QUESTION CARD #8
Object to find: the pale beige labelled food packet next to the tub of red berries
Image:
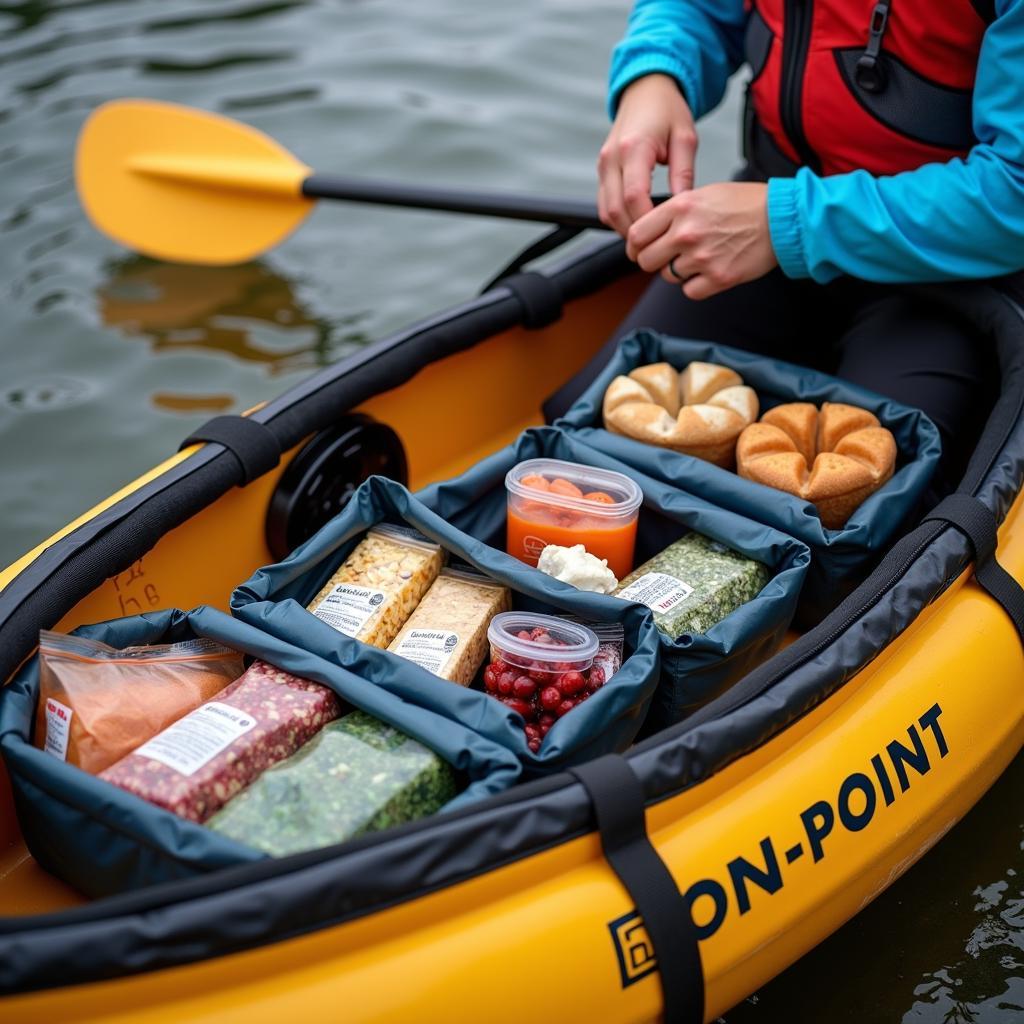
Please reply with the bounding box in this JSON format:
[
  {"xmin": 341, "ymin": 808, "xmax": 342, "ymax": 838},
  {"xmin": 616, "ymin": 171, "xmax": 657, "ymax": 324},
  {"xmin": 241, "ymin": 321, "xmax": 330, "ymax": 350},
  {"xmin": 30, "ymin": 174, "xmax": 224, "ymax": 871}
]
[{"xmin": 388, "ymin": 568, "xmax": 512, "ymax": 686}]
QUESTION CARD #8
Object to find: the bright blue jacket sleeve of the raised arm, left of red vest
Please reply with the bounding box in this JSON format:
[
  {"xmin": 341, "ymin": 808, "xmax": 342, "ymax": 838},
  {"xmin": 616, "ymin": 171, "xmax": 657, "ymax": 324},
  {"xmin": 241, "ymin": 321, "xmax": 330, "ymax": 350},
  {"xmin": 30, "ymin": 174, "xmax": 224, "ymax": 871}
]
[{"xmin": 608, "ymin": 0, "xmax": 746, "ymax": 118}]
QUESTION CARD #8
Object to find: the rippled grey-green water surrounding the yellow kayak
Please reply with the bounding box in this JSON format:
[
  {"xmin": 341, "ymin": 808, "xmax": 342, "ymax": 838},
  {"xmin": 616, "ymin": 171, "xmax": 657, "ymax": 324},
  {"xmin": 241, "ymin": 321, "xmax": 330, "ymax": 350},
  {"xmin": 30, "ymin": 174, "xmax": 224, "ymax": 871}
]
[{"xmin": 0, "ymin": 0, "xmax": 1024, "ymax": 1024}]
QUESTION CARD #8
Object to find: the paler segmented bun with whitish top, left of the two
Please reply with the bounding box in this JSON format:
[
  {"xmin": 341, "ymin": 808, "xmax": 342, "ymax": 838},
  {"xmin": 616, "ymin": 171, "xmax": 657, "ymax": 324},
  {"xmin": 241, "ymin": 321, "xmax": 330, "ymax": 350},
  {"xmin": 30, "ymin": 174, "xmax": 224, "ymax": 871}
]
[{"xmin": 602, "ymin": 362, "xmax": 758, "ymax": 468}]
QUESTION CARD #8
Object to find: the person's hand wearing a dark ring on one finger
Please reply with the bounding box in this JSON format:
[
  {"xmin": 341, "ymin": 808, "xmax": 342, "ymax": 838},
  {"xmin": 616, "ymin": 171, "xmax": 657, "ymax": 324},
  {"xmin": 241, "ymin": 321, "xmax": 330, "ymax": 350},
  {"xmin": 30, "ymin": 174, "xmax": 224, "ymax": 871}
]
[{"xmin": 626, "ymin": 181, "xmax": 778, "ymax": 299}]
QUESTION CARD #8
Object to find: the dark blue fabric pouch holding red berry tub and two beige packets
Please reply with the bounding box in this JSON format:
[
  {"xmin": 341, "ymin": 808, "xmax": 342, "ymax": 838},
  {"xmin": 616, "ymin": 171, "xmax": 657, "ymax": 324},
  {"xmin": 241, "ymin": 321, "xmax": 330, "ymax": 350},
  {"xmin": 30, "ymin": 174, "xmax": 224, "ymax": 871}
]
[{"xmin": 231, "ymin": 477, "xmax": 658, "ymax": 774}]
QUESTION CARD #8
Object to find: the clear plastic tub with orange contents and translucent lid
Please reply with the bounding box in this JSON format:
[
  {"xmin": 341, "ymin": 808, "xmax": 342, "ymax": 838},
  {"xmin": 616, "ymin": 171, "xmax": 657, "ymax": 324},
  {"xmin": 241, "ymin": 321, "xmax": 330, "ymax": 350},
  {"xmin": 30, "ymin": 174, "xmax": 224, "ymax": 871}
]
[{"xmin": 505, "ymin": 459, "xmax": 643, "ymax": 578}]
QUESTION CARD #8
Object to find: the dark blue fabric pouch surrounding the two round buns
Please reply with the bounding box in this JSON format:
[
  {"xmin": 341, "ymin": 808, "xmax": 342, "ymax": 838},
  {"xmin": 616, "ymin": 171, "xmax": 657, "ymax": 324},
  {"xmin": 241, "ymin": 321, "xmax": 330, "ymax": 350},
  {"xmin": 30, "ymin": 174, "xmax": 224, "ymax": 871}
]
[{"xmin": 556, "ymin": 330, "xmax": 940, "ymax": 627}]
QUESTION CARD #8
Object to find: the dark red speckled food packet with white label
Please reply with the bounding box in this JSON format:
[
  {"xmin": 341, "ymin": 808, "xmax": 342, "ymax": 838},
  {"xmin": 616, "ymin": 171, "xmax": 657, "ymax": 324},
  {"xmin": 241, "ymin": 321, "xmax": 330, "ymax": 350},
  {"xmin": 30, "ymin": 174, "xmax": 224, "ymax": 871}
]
[{"xmin": 99, "ymin": 662, "xmax": 341, "ymax": 823}]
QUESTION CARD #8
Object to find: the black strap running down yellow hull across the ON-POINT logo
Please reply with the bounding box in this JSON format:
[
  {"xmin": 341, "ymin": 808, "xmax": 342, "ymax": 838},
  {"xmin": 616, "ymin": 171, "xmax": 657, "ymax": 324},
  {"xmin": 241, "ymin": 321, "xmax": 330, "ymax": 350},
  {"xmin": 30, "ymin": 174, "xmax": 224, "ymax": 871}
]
[{"xmin": 569, "ymin": 754, "xmax": 705, "ymax": 1024}]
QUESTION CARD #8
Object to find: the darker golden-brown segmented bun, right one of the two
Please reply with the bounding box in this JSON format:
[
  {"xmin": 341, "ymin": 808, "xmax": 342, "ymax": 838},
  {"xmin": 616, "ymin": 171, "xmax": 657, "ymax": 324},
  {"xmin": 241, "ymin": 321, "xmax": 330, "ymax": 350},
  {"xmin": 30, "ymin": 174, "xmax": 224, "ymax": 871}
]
[{"xmin": 736, "ymin": 401, "xmax": 896, "ymax": 529}]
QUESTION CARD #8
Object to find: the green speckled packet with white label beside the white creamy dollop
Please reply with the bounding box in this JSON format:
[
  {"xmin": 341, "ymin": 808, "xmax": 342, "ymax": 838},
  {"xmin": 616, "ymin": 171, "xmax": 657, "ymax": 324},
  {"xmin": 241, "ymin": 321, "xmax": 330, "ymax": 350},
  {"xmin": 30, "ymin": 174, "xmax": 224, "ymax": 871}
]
[{"xmin": 615, "ymin": 532, "xmax": 771, "ymax": 640}]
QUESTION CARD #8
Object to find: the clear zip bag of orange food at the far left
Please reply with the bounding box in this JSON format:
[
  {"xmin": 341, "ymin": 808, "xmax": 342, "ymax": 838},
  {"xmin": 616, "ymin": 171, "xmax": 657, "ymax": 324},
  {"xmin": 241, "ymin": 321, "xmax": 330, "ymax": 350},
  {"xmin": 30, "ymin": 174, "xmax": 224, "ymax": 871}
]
[{"xmin": 36, "ymin": 630, "xmax": 243, "ymax": 775}]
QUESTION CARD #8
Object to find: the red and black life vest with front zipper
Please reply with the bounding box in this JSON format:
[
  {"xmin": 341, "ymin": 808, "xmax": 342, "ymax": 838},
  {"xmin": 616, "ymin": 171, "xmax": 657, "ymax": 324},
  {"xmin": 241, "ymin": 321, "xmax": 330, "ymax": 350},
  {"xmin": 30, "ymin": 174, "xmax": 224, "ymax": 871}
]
[{"xmin": 746, "ymin": 0, "xmax": 992, "ymax": 175}]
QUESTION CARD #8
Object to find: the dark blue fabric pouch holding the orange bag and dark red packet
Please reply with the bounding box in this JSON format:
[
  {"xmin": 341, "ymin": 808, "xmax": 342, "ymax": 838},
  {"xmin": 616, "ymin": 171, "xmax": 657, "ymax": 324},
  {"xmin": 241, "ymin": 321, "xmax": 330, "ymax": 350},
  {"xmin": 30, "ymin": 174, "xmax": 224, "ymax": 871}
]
[{"xmin": 0, "ymin": 607, "xmax": 521, "ymax": 896}]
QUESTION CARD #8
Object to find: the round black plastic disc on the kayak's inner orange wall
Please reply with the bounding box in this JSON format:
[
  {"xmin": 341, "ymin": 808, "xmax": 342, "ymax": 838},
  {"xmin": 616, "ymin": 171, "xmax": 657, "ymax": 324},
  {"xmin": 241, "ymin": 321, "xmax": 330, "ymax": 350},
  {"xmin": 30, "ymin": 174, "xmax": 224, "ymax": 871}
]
[{"xmin": 266, "ymin": 413, "xmax": 409, "ymax": 561}]
